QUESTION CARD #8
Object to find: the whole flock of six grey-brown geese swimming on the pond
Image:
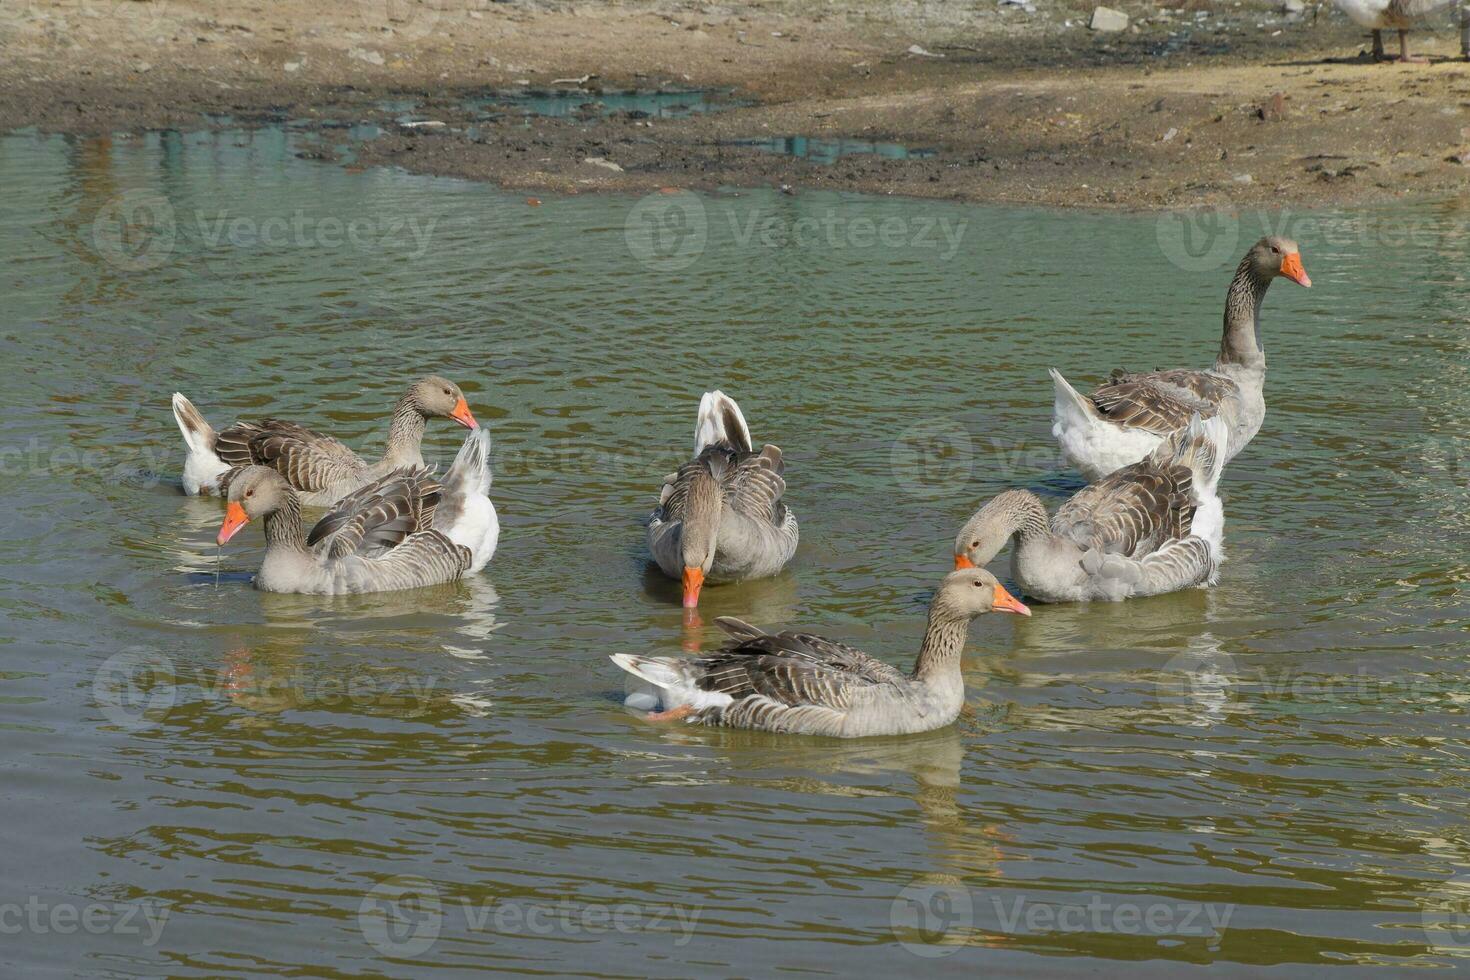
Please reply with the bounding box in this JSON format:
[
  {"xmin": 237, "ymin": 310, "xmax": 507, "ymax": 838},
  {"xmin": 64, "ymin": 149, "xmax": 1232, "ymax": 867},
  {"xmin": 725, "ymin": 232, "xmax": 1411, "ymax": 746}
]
[{"xmin": 173, "ymin": 237, "xmax": 1311, "ymax": 738}]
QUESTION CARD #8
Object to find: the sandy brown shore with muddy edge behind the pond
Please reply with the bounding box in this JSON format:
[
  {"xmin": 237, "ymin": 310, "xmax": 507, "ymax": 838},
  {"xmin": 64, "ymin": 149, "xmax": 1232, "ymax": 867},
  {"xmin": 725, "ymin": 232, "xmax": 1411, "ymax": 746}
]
[{"xmin": 0, "ymin": 0, "xmax": 1470, "ymax": 207}]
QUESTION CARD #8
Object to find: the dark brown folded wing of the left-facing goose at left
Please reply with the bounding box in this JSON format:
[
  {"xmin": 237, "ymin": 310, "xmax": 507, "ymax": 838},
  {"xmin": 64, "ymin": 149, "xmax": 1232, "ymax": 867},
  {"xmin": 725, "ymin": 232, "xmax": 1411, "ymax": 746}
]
[{"xmin": 306, "ymin": 466, "xmax": 442, "ymax": 558}]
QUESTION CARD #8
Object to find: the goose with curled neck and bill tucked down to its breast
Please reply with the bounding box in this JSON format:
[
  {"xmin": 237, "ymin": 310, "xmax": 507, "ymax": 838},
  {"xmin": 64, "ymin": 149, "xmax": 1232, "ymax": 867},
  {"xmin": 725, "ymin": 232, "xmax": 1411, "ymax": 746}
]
[{"xmin": 954, "ymin": 414, "xmax": 1226, "ymax": 602}]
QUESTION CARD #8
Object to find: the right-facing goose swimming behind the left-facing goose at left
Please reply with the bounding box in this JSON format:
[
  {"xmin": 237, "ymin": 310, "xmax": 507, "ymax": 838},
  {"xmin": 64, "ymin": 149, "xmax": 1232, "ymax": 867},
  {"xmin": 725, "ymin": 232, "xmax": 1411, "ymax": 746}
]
[{"xmin": 173, "ymin": 375, "xmax": 479, "ymax": 507}]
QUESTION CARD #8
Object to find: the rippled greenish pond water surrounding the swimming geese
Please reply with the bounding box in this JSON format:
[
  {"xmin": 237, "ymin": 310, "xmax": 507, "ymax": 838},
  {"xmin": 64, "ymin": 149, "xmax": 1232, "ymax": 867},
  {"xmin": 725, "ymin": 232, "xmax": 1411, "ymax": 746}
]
[{"xmin": 0, "ymin": 129, "xmax": 1470, "ymax": 977}]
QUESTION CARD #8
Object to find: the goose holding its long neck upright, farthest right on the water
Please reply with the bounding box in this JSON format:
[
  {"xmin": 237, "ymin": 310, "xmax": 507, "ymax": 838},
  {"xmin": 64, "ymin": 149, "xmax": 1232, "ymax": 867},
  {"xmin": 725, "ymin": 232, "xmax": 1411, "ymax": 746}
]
[{"xmin": 1051, "ymin": 235, "xmax": 1311, "ymax": 480}]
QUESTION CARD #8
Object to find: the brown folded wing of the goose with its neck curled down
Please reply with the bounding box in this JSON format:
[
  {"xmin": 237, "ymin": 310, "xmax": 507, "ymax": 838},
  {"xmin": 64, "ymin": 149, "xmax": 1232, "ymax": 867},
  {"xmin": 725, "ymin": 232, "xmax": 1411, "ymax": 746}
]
[{"xmin": 1051, "ymin": 460, "xmax": 1194, "ymax": 558}]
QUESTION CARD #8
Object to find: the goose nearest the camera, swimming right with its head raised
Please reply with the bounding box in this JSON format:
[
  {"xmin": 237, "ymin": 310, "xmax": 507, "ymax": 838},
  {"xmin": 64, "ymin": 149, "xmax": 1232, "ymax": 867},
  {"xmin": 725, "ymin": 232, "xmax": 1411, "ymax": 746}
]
[{"xmin": 612, "ymin": 569, "xmax": 1030, "ymax": 738}]
